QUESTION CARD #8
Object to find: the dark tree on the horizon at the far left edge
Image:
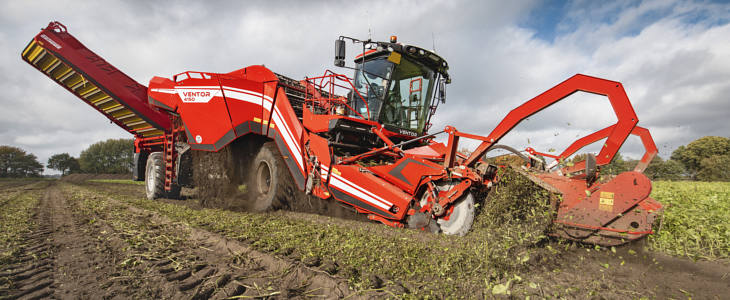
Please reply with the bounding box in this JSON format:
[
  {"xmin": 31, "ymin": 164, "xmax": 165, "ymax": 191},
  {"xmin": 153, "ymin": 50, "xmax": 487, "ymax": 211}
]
[{"xmin": 0, "ymin": 146, "xmax": 43, "ymax": 177}]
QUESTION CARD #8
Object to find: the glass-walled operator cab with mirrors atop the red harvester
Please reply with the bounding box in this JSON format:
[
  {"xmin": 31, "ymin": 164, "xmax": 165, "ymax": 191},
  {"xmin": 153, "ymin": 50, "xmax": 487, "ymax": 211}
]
[{"xmin": 335, "ymin": 36, "xmax": 450, "ymax": 140}]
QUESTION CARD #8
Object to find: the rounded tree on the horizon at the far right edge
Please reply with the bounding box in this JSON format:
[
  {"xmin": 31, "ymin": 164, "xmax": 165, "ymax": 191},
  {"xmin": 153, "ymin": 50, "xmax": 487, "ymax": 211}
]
[{"xmin": 671, "ymin": 136, "xmax": 730, "ymax": 179}]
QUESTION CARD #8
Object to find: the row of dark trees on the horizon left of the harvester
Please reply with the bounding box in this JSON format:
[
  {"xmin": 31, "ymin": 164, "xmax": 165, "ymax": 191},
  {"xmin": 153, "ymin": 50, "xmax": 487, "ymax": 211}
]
[{"xmin": 0, "ymin": 139, "xmax": 134, "ymax": 178}]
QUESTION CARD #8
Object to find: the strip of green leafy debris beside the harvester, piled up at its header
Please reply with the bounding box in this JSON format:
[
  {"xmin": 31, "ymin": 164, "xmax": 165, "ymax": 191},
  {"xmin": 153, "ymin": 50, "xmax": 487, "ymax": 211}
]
[{"xmin": 72, "ymin": 169, "xmax": 552, "ymax": 298}]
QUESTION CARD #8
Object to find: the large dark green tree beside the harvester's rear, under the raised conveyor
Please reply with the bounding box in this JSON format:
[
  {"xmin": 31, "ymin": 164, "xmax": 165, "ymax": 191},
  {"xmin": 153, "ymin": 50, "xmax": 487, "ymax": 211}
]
[{"xmin": 79, "ymin": 139, "xmax": 134, "ymax": 174}]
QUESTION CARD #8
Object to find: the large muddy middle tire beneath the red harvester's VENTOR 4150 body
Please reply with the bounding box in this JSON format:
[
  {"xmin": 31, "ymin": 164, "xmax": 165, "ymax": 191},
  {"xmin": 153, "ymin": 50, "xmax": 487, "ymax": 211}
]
[{"xmin": 247, "ymin": 141, "xmax": 296, "ymax": 212}]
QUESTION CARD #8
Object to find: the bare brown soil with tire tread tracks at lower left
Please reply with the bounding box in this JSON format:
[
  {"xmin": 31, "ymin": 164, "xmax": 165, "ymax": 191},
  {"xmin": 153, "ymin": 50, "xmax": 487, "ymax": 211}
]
[{"xmin": 0, "ymin": 179, "xmax": 376, "ymax": 299}]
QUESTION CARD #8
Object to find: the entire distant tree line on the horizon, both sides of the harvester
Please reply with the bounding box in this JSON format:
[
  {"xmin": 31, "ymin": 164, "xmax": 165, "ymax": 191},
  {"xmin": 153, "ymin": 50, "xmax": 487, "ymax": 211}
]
[{"xmin": 0, "ymin": 136, "xmax": 730, "ymax": 181}]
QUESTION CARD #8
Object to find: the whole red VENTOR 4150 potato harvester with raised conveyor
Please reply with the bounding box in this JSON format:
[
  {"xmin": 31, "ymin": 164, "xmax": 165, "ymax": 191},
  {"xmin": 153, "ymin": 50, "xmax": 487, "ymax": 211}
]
[{"xmin": 21, "ymin": 22, "xmax": 662, "ymax": 245}]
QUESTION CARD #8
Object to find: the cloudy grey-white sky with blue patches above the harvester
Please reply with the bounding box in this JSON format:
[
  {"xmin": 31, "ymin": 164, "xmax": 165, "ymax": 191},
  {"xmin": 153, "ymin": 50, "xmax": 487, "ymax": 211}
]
[{"xmin": 0, "ymin": 0, "xmax": 730, "ymax": 173}]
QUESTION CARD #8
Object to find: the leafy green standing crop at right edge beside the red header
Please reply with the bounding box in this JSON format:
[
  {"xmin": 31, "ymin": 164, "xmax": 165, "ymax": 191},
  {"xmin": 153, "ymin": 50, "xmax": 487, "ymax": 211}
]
[{"xmin": 649, "ymin": 181, "xmax": 730, "ymax": 259}]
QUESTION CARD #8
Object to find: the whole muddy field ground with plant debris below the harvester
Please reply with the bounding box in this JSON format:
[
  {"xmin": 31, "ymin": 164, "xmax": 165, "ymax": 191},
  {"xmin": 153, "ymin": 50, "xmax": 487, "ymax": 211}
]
[{"xmin": 0, "ymin": 178, "xmax": 730, "ymax": 299}]
